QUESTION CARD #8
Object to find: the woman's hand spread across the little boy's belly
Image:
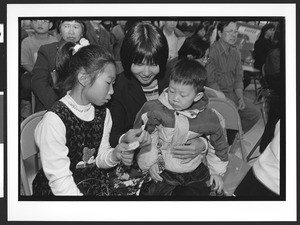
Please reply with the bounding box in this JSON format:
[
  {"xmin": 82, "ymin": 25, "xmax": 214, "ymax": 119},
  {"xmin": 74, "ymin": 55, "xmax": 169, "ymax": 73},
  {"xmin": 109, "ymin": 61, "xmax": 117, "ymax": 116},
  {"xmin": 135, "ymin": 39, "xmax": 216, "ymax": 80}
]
[{"xmin": 172, "ymin": 138, "xmax": 206, "ymax": 163}]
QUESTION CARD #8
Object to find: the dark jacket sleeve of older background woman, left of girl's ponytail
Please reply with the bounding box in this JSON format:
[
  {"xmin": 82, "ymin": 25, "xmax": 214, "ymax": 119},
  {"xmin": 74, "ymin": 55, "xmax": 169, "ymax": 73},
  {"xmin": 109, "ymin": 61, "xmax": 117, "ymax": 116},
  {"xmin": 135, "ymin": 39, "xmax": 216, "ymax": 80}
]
[{"xmin": 31, "ymin": 46, "xmax": 58, "ymax": 109}]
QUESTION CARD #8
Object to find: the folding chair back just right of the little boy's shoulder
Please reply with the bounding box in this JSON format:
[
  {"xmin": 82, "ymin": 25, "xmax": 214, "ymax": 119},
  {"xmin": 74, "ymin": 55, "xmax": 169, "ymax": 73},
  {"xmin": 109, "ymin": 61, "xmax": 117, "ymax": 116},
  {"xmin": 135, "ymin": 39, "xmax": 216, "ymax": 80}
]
[{"xmin": 208, "ymin": 98, "xmax": 248, "ymax": 162}]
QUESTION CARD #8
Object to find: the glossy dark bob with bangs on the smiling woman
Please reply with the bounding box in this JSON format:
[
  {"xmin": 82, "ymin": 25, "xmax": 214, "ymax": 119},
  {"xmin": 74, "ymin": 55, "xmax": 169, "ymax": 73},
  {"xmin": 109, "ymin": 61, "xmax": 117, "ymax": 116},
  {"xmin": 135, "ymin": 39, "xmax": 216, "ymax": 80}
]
[{"xmin": 120, "ymin": 22, "xmax": 169, "ymax": 77}]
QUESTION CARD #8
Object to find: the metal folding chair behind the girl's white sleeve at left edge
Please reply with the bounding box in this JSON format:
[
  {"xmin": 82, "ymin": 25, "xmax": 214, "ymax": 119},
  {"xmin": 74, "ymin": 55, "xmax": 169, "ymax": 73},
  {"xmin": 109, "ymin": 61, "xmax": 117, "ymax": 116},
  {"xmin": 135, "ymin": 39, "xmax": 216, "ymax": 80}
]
[{"xmin": 20, "ymin": 111, "xmax": 46, "ymax": 195}]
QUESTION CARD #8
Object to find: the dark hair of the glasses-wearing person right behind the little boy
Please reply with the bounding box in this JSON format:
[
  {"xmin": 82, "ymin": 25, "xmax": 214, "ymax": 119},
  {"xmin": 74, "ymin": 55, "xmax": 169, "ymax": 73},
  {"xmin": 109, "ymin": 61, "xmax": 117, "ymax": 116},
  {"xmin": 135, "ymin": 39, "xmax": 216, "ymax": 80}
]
[{"xmin": 178, "ymin": 35, "xmax": 209, "ymax": 59}]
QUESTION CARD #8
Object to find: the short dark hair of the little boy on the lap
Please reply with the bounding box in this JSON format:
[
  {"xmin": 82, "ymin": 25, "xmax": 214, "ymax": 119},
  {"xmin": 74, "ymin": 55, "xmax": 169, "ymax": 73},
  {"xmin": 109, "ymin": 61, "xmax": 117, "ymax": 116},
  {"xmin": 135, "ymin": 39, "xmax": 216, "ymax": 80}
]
[{"xmin": 170, "ymin": 59, "xmax": 207, "ymax": 93}]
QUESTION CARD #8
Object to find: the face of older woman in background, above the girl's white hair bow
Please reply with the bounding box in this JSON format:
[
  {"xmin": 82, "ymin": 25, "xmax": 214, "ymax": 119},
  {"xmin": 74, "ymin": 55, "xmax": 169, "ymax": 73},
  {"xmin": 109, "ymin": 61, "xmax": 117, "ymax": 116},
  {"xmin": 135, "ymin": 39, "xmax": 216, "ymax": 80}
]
[{"xmin": 60, "ymin": 20, "xmax": 83, "ymax": 43}]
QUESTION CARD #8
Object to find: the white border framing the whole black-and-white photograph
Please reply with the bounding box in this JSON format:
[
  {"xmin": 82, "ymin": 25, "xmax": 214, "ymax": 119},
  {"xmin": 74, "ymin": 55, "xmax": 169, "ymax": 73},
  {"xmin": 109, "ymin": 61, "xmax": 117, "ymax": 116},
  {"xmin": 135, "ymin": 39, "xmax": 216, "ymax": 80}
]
[{"xmin": 6, "ymin": 3, "xmax": 297, "ymax": 221}]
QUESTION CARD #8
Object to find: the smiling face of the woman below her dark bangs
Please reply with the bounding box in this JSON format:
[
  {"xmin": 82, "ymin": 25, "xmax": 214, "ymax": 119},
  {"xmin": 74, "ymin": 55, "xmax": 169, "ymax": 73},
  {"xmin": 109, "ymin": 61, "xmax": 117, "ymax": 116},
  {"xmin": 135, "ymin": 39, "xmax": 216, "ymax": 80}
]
[{"xmin": 131, "ymin": 60, "xmax": 159, "ymax": 86}]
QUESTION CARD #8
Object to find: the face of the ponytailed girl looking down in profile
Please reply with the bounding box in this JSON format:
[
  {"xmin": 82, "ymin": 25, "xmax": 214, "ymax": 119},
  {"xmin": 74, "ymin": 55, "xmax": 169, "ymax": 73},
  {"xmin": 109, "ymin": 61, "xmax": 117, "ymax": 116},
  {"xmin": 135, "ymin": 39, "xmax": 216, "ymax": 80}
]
[{"xmin": 86, "ymin": 63, "xmax": 116, "ymax": 106}]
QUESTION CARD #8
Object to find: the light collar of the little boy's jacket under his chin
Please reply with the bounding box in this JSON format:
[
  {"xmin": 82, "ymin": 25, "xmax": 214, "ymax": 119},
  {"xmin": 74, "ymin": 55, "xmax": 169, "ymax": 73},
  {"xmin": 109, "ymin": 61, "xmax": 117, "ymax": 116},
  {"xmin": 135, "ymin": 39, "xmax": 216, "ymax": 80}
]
[{"xmin": 158, "ymin": 88, "xmax": 206, "ymax": 119}]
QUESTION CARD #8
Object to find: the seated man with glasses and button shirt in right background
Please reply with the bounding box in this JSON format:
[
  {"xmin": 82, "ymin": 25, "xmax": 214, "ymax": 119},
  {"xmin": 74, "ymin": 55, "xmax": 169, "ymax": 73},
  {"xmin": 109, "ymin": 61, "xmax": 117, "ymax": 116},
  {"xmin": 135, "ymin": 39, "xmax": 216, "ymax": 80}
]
[{"xmin": 206, "ymin": 21, "xmax": 261, "ymax": 133}]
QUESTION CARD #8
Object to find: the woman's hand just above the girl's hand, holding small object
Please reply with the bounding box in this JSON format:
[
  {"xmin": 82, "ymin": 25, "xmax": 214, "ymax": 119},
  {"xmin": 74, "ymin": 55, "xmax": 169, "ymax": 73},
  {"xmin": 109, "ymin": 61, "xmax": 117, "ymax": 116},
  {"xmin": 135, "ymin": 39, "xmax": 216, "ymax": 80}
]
[{"xmin": 122, "ymin": 128, "xmax": 151, "ymax": 147}]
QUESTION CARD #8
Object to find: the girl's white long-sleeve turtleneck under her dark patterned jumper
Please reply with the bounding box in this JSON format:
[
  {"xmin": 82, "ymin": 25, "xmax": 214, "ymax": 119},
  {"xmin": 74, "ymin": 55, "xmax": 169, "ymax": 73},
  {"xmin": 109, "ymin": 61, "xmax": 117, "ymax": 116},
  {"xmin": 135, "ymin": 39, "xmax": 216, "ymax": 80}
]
[{"xmin": 34, "ymin": 95, "xmax": 118, "ymax": 195}]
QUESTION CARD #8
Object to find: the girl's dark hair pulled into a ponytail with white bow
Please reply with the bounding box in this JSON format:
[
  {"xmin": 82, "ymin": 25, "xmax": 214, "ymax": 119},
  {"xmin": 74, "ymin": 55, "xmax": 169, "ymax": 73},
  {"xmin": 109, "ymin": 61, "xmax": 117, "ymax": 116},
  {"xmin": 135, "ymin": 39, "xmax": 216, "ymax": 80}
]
[{"xmin": 54, "ymin": 42, "xmax": 116, "ymax": 97}]
